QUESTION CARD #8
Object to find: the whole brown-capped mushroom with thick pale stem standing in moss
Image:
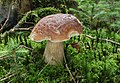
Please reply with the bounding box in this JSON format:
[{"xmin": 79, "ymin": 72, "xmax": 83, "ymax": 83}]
[{"xmin": 30, "ymin": 14, "xmax": 82, "ymax": 65}]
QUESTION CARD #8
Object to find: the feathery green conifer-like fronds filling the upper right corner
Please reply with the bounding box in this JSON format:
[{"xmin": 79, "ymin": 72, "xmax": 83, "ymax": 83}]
[{"xmin": 70, "ymin": 0, "xmax": 120, "ymax": 30}]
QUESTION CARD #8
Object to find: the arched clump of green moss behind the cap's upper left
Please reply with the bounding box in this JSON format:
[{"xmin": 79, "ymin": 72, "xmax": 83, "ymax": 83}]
[{"xmin": 20, "ymin": 7, "xmax": 61, "ymax": 24}]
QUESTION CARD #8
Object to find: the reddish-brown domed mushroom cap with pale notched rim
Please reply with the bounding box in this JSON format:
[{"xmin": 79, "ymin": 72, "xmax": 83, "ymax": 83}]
[{"xmin": 30, "ymin": 14, "xmax": 82, "ymax": 42}]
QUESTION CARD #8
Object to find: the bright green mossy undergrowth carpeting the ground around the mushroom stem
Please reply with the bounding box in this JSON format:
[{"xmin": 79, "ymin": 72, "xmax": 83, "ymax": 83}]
[{"xmin": 0, "ymin": 28, "xmax": 120, "ymax": 83}]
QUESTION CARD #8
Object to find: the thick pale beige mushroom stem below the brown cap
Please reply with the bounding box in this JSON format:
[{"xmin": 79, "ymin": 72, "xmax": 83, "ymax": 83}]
[{"xmin": 43, "ymin": 41, "xmax": 64, "ymax": 65}]
